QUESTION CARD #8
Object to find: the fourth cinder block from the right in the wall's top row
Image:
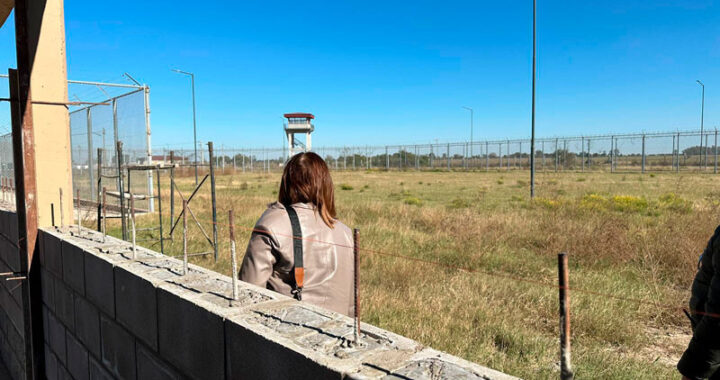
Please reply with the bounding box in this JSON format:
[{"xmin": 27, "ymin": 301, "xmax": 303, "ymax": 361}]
[{"xmin": 85, "ymin": 254, "xmax": 115, "ymax": 318}]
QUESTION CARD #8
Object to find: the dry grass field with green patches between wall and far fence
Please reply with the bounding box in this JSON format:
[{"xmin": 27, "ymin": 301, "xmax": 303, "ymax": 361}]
[{"xmin": 95, "ymin": 171, "xmax": 720, "ymax": 379}]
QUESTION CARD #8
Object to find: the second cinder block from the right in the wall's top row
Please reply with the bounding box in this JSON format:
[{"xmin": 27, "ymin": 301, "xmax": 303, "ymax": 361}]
[{"xmin": 158, "ymin": 288, "xmax": 225, "ymax": 380}]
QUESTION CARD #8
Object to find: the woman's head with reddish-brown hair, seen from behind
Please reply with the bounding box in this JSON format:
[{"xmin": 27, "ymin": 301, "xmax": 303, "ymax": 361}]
[{"xmin": 278, "ymin": 152, "xmax": 335, "ymax": 228}]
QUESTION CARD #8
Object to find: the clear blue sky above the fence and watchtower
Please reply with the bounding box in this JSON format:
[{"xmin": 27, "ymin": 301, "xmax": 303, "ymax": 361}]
[{"xmin": 0, "ymin": 0, "xmax": 720, "ymax": 147}]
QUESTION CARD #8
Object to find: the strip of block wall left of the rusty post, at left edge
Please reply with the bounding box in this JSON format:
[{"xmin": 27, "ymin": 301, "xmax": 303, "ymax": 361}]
[{"xmin": 0, "ymin": 209, "xmax": 26, "ymax": 379}]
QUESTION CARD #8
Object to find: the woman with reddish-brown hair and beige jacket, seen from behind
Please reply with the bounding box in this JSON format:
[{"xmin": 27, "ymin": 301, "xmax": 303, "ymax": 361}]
[{"xmin": 240, "ymin": 152, "xmax": 353, "ymax": 315}]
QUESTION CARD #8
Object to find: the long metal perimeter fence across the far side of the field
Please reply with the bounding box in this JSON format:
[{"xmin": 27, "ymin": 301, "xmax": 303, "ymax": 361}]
[{"xmin": 155, "ymin": 130, "xmax": 718, "ymax": 173}]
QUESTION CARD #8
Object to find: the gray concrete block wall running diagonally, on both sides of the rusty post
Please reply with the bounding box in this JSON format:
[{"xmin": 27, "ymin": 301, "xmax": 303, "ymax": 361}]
[{"xmin": 0, "ymin": 209, "xmax": 512, "ymax": 380}]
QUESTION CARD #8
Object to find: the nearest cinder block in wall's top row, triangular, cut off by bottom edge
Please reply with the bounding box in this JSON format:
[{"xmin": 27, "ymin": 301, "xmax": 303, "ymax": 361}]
[{"xmin": 225, "ymin": 320, "xmax": 343, "ymax": 379}]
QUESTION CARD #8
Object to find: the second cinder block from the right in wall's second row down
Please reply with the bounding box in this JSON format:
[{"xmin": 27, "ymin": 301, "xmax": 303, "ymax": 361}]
[{"xmin": 100, "ymin": 315, "xmax": 136, "ymax": 379}]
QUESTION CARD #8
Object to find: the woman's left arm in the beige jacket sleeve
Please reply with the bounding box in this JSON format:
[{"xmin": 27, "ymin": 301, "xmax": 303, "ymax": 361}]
[{"xmin": 240, "ymin": 225, "xmax": 278, "ymax": 288}]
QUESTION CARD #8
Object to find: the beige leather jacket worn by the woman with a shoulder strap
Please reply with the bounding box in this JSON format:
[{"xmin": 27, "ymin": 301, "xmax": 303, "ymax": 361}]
[{"xmin": 240, "ymin": 202, "xmax": 354, "ymax": 315}]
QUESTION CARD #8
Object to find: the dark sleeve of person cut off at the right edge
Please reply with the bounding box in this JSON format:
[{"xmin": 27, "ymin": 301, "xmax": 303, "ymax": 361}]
[{"xmin": 677, "ymin": 227, "xmax": 720, "ymax": 379}]
